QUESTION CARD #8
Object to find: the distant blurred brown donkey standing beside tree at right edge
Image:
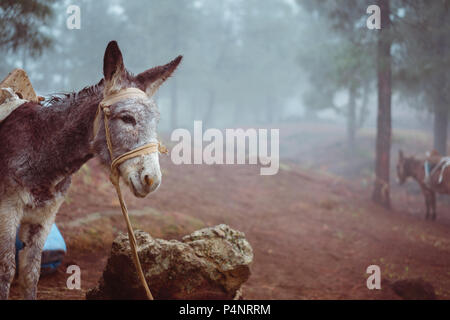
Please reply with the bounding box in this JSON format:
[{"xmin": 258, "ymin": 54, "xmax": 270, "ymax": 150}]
[{"xmin": 397, "ymin": 150, "xmax": 450, "ymax": 220}]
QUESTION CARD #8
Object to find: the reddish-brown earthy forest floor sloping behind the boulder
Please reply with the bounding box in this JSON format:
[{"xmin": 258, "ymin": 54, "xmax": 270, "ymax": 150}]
[{"xmin": 7, "ymin": 124, "xmax": 450, "ymax": 299}]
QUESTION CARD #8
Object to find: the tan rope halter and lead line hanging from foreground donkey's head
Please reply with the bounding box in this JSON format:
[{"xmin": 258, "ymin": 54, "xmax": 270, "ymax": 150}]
[{"xmin": 99, "ymin": 88, "xmax": 168, "ymax": 300}]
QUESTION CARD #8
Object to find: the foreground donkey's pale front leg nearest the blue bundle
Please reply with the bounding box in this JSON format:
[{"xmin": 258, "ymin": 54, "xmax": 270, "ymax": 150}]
[{"xmin": 19, "ymin": 217, "xmax": 54, "ymax": 300}]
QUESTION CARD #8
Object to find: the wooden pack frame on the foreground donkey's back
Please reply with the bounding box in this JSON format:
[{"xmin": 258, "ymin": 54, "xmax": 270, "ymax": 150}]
[{"xmin": 0, "ymin": 69, "xmax": 40, "ymax": 104}]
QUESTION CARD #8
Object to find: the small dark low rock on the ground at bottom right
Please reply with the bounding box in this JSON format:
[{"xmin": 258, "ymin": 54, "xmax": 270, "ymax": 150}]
[{"xmin": 390, "ymin": 278, "xmax": 436, "ymax": 300}]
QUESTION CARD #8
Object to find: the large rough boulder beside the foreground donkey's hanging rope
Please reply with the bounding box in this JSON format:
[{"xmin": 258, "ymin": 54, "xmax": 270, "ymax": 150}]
[{"xmin": 86, "ymin": 224, "xmax": 253, "ymax": 300}]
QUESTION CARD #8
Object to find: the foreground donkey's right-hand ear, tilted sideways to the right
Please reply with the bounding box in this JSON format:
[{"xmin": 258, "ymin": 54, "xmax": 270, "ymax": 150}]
[{"xmin": 136, "ymin": 56, "xmax": 183, "ymax": 97}]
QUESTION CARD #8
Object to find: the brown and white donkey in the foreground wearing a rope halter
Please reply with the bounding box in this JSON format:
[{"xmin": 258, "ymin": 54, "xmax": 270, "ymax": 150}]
[{"xmin": 0, "ymin": 41, "xmax": 182, "ymax": 299}]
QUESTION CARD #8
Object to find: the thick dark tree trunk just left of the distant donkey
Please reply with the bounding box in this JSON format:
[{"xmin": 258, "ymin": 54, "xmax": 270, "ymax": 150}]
[{"xmin": 372, "ymin": 0, "xmax": 392, "ymax": 208}]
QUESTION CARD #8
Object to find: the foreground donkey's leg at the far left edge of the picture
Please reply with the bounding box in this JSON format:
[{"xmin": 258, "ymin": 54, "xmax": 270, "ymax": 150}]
[{"xmin": 0, "ymin": 199, "xmax": 22, "ymax": 300}]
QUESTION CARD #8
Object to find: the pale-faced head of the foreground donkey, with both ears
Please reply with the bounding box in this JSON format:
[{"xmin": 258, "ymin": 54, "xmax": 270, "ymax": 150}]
[{"xmin": 93, "ymin": 41, "xmax": 181, "ymax": 197}]
